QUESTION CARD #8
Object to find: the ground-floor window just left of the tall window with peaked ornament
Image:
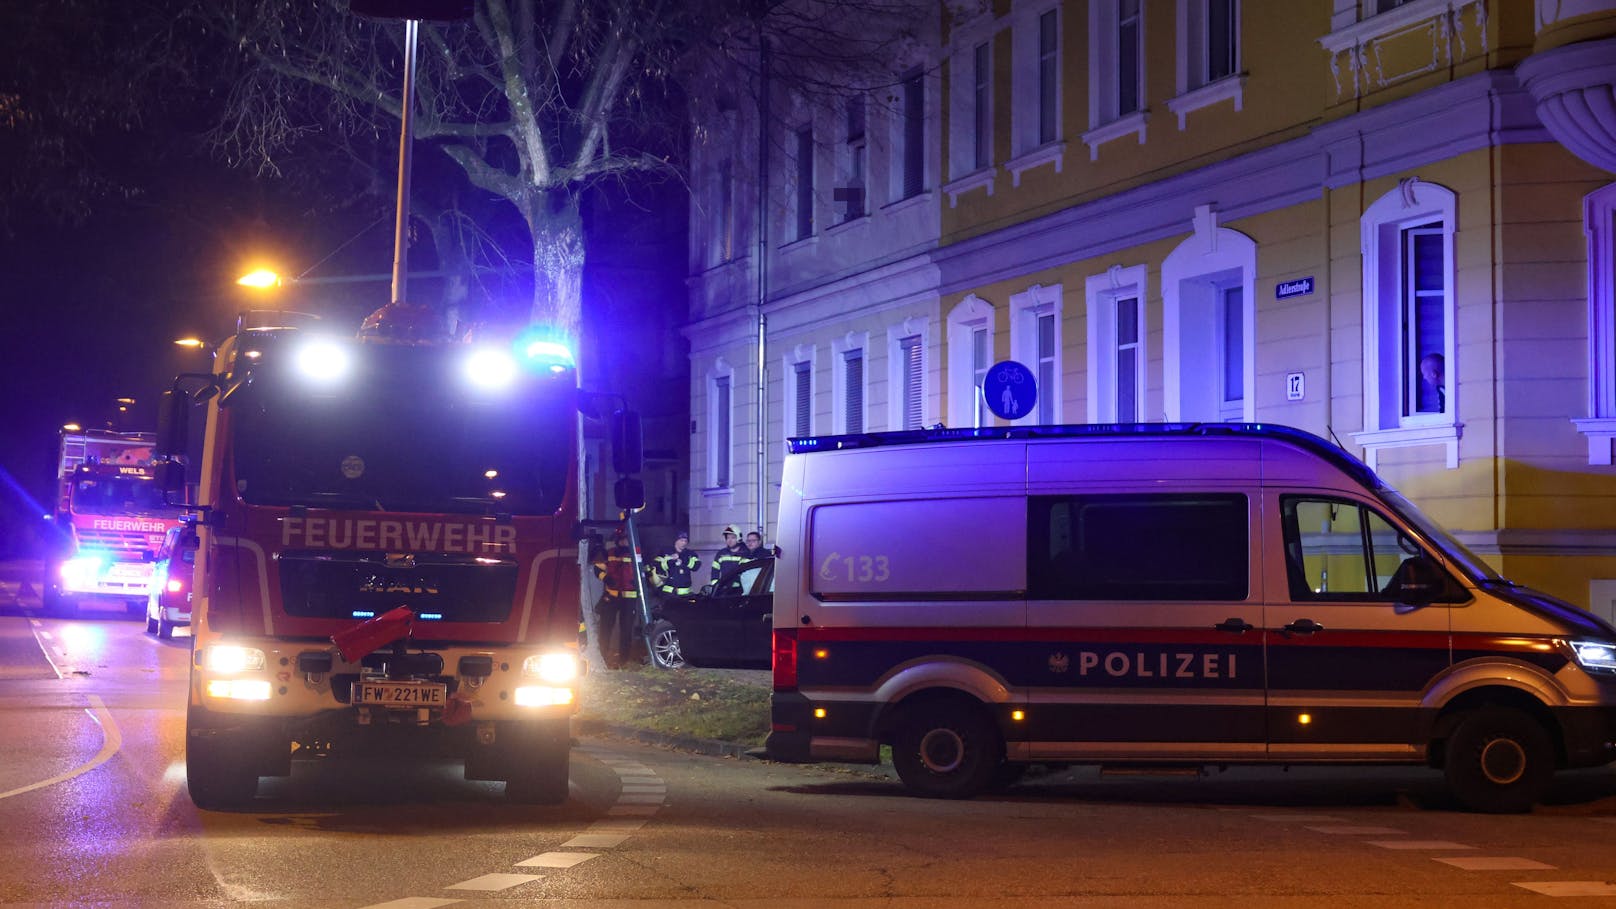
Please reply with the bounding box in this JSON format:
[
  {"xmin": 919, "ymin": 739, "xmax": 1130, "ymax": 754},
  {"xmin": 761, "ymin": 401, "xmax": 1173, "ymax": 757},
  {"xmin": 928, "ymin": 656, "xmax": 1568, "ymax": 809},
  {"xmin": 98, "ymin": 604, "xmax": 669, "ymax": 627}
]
[{"xmin": 1086, "ymin": 265, "xmax": 1149, "ymax": 422}]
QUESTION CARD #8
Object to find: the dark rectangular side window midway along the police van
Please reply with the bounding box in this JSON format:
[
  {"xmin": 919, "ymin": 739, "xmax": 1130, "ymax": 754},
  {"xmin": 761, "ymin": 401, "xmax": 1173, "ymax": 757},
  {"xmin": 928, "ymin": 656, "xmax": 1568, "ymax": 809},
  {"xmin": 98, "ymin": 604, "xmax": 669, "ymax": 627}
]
[{"xmin": 1028, "ymin": 493, "xmax": 1251, "ymax": 602}]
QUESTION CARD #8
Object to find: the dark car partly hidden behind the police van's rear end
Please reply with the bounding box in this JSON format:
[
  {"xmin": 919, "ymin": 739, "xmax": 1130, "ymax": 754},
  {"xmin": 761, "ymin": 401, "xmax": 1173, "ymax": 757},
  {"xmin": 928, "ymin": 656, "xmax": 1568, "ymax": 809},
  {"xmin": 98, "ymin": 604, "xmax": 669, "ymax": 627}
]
[{"xmin": 646, "ymin": 558, "xmax": 774, "ymax": 670}]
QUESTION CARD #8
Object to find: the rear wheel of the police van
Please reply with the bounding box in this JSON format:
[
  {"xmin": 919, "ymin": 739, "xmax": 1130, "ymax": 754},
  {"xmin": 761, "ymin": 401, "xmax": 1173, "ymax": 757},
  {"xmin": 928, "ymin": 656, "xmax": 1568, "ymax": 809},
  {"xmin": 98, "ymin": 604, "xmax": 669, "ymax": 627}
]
[{"xmin": 892, "ymin": 700, "xmax": 1004, "ymax": 799}]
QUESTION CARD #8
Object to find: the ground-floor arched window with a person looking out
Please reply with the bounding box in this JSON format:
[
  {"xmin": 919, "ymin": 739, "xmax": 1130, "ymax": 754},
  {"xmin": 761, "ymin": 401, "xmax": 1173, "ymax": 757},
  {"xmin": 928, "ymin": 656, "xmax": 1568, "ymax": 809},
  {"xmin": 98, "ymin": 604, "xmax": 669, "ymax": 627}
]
[{"xmin": 1356, "ymin": 180, "xmax": 1459, "ymax": 467}]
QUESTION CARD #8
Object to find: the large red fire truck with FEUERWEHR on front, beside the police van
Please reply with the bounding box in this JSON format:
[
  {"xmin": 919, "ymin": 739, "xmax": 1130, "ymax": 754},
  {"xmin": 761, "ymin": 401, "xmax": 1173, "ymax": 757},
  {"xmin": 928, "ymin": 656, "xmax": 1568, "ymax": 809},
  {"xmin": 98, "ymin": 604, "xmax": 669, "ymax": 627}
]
[{"xmin": 158, "ymin": 304, "xmax": 643, "ymax": 809}]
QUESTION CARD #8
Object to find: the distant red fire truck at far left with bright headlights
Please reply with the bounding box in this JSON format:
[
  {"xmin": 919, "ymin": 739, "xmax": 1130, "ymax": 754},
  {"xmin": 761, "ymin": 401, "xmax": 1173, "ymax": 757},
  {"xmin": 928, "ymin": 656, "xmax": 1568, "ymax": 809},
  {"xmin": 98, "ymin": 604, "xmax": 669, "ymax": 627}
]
[{"xmin": 42, "ymin": 429, "xmax": 179, "ymax": 616}]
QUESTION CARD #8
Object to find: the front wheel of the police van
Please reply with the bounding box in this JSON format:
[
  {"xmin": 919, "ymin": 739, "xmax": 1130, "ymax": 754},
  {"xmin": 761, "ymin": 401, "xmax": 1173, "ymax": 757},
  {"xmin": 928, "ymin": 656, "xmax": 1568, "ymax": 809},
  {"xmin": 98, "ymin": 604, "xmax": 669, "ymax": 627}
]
[{"xmin": 1443, "ymin": 707, "xmax": 1555, "ymax": 814}]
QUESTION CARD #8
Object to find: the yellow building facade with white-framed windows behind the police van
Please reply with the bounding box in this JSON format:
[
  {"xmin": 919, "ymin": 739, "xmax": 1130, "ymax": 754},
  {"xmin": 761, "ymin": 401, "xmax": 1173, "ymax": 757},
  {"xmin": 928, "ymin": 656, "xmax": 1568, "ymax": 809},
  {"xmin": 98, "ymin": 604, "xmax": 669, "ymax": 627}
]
[{"xmin": 688, "ymin": 0, "xmax": 1616, "ymax": 608}]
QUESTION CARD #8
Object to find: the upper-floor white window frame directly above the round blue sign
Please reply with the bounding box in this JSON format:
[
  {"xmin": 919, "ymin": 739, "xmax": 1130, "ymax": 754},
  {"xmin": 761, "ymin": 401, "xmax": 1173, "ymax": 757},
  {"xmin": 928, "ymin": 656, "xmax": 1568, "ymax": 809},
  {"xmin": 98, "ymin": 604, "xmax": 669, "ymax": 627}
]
[{"xmin": 1005, "ymin": 0, "xmax": 1067, "ymax": 186}]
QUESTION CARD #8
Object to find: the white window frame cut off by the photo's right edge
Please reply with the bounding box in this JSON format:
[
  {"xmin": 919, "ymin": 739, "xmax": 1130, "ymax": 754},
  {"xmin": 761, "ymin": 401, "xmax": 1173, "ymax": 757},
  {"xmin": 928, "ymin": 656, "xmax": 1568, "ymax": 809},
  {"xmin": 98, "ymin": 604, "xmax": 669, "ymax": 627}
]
[{"xmin": 1571, "ymin": 183, "xmax": 1616, "ymax": 466}]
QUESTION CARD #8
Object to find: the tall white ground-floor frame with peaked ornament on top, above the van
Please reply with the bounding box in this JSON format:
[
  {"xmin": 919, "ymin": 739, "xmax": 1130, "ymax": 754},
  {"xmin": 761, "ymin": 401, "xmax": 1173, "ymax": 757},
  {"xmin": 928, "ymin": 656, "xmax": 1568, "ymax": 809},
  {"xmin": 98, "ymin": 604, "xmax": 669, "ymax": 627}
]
[{"xmin": 1162, "ymin": 205, "xmax": 1257, "ymax": 422}]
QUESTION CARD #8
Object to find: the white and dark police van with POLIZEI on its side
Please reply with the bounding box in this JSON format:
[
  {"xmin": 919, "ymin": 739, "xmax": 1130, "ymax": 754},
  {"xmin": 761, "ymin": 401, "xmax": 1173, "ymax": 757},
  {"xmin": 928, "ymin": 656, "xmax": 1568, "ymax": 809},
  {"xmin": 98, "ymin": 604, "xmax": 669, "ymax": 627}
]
[{"xmin": 768, "ymin": 424, "xmax": 1616, "ymax": 812}]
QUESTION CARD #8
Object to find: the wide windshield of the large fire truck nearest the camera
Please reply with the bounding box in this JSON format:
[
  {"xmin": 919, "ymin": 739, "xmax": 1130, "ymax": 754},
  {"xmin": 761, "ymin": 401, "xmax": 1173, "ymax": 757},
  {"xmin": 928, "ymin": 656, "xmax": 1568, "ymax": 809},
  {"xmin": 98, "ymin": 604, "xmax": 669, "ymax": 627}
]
[{"xmin": 229, "ymin": 348, "xmax": 577, "ymax": 514}]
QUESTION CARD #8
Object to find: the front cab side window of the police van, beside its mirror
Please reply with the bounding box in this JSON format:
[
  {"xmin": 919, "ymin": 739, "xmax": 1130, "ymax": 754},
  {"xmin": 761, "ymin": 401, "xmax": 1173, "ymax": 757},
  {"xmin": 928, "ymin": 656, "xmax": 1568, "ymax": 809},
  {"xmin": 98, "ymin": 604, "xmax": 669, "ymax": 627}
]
[{"xmin": 1280, "ymin": 495, "xmax": 1419, "ymax": 600}]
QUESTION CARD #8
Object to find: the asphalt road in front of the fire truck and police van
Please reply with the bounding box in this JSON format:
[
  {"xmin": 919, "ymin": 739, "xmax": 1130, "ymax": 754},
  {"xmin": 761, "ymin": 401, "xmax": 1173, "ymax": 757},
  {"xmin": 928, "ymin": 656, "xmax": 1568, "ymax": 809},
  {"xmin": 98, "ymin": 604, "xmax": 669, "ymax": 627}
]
[{"xmin": 0, "ymin": 572, "xmax": 1616, "ymax": 909}]
